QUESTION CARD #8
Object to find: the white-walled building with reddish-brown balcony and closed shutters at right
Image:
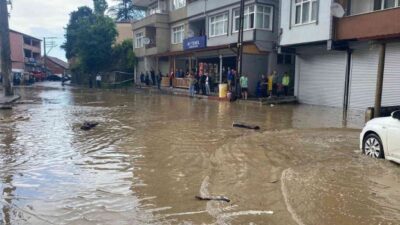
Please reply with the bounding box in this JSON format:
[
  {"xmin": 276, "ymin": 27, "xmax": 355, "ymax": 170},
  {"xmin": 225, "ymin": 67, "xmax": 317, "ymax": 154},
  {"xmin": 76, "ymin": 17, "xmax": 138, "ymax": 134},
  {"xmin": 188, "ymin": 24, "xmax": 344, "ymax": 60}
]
[{"xmin": 280, "ymin": 0, "xmax": 400, "ymax": 110}]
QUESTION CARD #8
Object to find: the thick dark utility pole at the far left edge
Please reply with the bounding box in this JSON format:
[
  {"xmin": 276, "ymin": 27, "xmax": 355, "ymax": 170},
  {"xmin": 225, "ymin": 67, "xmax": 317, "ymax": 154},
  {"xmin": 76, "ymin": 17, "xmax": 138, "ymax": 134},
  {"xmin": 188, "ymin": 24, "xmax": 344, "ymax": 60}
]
[{"xmin": 0, "ymin": 0, "xmax": 14, "ymax": 96}]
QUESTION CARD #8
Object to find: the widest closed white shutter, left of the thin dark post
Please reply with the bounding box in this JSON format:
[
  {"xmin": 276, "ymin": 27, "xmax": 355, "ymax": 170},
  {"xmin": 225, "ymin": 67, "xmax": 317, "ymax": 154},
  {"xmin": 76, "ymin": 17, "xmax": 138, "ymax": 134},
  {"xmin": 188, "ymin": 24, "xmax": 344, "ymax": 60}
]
[{"xmin": 297, "ymin": 52, "xmax": 346, "ymax": 107}]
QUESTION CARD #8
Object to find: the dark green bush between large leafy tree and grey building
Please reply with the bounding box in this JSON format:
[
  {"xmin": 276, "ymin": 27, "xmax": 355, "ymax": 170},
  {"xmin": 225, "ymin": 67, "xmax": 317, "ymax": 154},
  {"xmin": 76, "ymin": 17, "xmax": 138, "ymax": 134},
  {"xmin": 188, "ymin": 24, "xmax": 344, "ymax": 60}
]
[{"xmin": 112, "ymin": 39, "xmax": 137, "ymax": 73}]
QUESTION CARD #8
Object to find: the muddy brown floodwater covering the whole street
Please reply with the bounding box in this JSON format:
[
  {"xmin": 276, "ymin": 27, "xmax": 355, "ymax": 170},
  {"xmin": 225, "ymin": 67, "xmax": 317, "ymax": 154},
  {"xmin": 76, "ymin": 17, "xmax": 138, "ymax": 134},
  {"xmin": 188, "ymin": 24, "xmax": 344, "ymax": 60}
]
[{"xmin": 0, "ymin": 83, "xmax": 400, "ymax": 225}]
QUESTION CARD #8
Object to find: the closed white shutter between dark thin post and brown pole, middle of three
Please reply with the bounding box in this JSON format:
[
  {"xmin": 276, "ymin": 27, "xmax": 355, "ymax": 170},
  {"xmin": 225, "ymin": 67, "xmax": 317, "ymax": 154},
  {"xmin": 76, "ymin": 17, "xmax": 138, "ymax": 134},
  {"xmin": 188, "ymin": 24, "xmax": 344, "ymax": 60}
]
[{"xmin": 349, "ymin": 47, "xmax": 379, "ymax": 110}]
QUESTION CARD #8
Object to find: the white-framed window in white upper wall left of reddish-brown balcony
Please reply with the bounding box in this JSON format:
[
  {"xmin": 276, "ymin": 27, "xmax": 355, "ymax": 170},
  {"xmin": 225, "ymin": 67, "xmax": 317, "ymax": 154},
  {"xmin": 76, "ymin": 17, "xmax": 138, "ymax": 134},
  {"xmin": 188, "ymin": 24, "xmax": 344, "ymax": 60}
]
[{"xmin": 294, "ymin": 0, "xmax": 318, "ymax": 25}]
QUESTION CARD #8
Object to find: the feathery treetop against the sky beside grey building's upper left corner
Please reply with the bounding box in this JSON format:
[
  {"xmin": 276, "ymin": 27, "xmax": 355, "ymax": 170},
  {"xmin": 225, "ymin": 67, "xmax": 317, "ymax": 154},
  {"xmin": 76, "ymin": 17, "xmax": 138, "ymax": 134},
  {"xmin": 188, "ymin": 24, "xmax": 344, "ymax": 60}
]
[{"xmin": 108, "ymin": 0, "xmax": 145, "ymax": 22}]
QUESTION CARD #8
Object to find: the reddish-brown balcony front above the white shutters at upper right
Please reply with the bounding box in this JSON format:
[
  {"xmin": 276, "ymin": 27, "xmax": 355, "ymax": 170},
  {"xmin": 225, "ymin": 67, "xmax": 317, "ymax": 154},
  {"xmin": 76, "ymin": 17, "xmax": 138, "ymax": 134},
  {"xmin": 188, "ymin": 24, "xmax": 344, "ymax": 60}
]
[{"xmin": 336, "ymin": 8, "xmax": 400, "ymax": 40}]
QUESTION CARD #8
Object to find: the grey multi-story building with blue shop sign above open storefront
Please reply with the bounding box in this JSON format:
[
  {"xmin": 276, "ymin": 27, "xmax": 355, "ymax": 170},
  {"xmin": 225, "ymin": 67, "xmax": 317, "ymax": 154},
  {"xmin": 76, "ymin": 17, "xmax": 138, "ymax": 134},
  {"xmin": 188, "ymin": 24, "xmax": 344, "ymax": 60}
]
[{"xmin": 133, "ymin": 0, "xmax": 294, "ymax": 94}]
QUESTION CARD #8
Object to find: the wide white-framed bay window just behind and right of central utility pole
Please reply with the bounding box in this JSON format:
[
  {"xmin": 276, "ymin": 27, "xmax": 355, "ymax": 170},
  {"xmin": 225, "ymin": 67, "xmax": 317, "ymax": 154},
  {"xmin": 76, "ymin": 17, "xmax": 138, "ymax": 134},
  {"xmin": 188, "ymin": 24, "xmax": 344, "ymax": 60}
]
[{"xmin": 233, "ymin": 5, "xmax": 273, "ymax": 31}]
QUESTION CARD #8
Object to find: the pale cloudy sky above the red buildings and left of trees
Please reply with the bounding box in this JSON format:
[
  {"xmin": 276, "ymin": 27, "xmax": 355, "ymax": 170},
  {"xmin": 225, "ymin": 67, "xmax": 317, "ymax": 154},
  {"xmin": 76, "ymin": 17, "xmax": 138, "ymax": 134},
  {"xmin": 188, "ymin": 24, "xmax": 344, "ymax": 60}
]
[{"xmin": 9, "ymin": 0, "xmax": 115, "ymax": 60}]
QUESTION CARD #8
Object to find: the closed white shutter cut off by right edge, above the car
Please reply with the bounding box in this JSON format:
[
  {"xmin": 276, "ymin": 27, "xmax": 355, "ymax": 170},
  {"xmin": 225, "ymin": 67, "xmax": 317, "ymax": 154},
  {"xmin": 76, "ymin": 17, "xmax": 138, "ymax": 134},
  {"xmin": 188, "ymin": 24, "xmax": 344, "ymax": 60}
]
[{"xmin": 382, "ymin": 43, "xmax": 400, "ymax": 106}]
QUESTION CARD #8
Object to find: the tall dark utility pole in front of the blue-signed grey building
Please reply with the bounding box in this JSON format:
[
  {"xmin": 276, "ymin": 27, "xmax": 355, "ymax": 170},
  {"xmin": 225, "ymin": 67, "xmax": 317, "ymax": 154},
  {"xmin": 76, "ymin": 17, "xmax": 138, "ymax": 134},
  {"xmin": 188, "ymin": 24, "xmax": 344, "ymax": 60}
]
[{"xmin": 235, "ymin": 0, "xmax": 245, "ymax": 97}]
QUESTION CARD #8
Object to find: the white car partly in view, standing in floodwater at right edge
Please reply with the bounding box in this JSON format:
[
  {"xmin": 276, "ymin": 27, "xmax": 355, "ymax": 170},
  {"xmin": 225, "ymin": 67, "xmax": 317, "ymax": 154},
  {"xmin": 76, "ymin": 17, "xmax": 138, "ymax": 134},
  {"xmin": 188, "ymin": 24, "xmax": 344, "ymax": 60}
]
[{"xmin": 360, "ymin": 111, "xmax": 400, "ymax": 163}]
